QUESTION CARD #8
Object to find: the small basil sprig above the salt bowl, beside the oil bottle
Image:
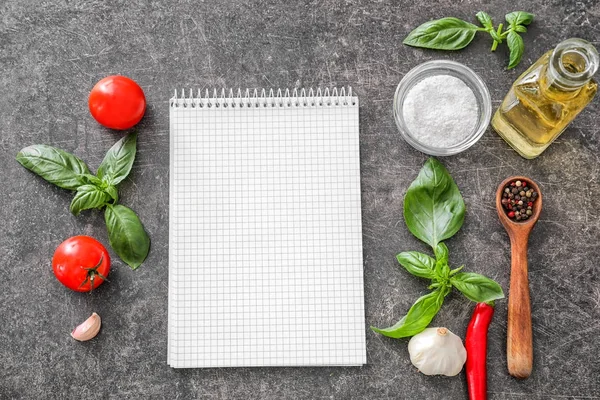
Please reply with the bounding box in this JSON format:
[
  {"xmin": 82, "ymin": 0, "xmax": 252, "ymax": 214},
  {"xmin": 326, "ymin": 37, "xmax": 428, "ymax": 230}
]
[{"xmin": 403, "ymin": 11, "xmax": 534, "ymax": 69}]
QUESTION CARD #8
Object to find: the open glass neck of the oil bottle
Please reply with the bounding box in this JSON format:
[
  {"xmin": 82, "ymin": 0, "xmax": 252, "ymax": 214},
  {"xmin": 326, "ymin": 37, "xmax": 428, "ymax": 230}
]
[{"xmin": 544, "ymin": 38, "xmax": 600, "ymax": 94}]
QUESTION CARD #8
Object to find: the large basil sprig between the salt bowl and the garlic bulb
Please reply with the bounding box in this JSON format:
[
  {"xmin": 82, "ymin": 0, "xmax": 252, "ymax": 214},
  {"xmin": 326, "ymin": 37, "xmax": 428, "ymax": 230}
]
[{"xmin": 371, "ymin": 158, "xmax": 504, "ymax": 338}]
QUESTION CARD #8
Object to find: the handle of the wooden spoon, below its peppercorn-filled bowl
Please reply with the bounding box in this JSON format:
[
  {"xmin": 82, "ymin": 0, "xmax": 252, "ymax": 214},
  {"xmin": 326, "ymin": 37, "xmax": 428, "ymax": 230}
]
[{"xmin": 506, "ymin": 235, "xmax": 533, "ymax": 379}]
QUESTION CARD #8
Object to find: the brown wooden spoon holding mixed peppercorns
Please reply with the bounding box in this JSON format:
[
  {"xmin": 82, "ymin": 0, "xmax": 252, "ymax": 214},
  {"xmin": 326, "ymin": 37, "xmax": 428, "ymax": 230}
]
[{"xmin": 496, "ymin": 176, "xmax": 542, "ymax": 379}]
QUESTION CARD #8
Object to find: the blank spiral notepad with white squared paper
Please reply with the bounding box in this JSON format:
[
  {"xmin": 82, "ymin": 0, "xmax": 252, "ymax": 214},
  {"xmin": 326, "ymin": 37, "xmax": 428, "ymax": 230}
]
[{"xmin": 167, "ymin": 89, "xmax": 366, "ymax": 368}]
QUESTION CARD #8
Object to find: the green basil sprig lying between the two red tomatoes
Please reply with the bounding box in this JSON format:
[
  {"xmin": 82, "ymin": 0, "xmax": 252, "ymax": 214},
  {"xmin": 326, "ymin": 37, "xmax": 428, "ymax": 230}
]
[{"xmin": 17, "ymin": 133, "xmax": 150, "ymax": 269}]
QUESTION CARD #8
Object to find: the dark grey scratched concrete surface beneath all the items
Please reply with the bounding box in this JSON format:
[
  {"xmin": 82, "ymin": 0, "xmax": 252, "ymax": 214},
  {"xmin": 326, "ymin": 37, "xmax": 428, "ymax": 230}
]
[{"xmin": 0, "ymin": 0, "xmax": 600, "ymax": 400}]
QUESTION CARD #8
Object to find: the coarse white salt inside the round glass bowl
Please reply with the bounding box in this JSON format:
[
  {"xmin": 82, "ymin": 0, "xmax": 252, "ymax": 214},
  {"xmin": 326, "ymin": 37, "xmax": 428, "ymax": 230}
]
[{"xmin": 402, "ymin": 75, "xmax": 479, "ymax": 148}]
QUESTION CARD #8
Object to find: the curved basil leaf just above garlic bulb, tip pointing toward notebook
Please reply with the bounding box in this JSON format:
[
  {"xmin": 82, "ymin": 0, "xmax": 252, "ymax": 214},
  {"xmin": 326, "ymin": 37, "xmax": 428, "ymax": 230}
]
[{"xmin": 371, "ymin": 289, "xmax": 444, "ymax": 339}]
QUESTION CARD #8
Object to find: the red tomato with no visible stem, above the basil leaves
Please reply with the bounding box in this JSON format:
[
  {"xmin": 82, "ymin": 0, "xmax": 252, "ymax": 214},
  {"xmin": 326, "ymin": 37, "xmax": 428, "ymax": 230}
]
[{"xmin": 88, "ymin": 75, "xmax": 146, "ymax": 130}]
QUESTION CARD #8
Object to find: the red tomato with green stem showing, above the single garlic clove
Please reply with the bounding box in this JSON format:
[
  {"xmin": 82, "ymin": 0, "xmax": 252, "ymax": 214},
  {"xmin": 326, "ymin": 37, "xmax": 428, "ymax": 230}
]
[{"xmin": 52, "ymin": 236, "xmax": 110, "ymax": 292}]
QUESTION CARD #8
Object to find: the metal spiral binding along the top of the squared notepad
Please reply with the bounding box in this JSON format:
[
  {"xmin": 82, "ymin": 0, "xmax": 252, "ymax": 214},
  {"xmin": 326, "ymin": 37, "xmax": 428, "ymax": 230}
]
[{"xmin": 170, "ymin": 87, "xmax": 357, "ymax": 108}]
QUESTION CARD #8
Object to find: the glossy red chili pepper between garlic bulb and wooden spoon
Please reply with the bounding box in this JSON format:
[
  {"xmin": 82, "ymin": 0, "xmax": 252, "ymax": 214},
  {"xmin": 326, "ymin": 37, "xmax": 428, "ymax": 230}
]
[{"xmin": 465, "ymin": 303, "xmax": 494, "ymax": 400}]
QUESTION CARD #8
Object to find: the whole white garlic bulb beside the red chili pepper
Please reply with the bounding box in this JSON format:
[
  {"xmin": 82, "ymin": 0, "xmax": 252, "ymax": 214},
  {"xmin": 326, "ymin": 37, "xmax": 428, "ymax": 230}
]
[{"xmin": 408, "ymin": 328, "xmax": 467, "ymax": 376}]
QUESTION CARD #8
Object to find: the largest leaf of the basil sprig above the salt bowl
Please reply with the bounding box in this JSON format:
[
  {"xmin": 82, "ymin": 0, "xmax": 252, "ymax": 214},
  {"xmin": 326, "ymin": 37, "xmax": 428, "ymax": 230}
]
[{"xmin": 403, "ymin": 17, "xmax": 479, "ymax": 50}]
